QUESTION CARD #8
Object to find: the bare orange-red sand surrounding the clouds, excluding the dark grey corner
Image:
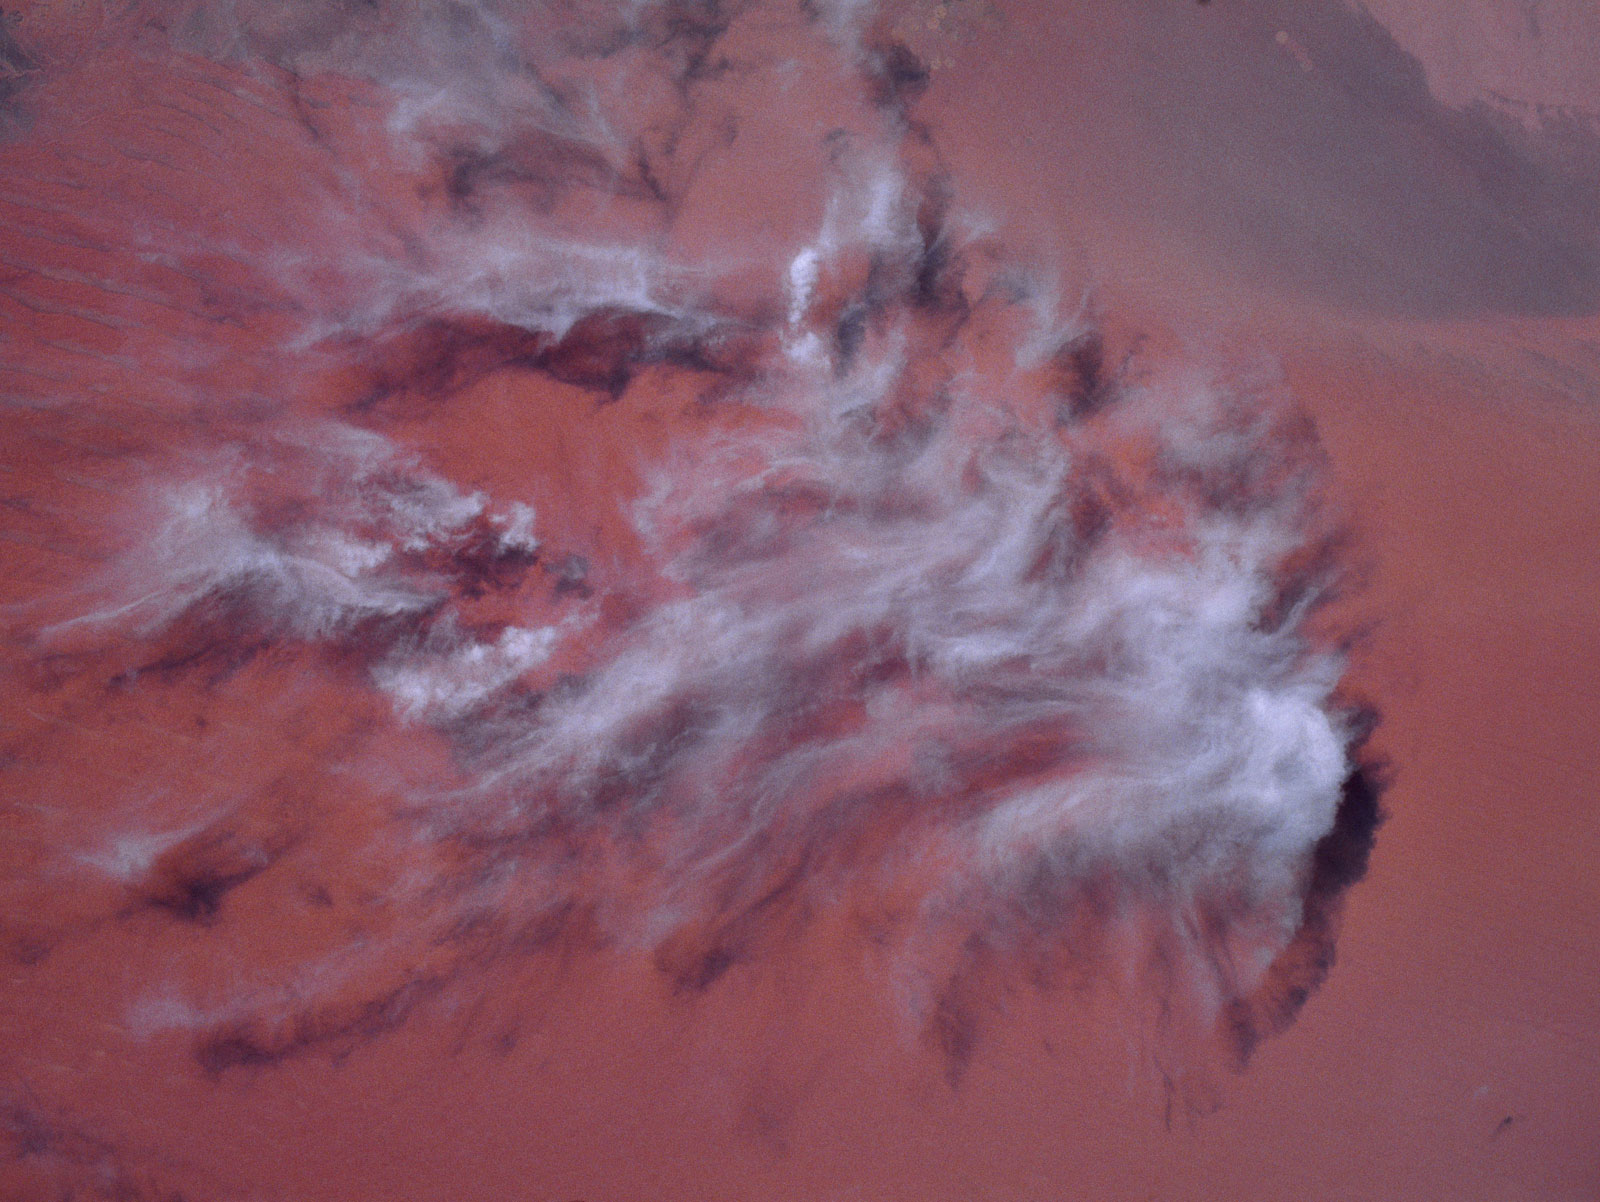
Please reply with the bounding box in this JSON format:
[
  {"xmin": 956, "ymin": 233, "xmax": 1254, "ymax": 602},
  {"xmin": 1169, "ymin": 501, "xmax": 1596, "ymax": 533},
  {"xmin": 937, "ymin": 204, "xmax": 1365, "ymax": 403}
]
[{"xmin": 0, "ymin": 0, "xmax": 1600, "ymax": 1202}]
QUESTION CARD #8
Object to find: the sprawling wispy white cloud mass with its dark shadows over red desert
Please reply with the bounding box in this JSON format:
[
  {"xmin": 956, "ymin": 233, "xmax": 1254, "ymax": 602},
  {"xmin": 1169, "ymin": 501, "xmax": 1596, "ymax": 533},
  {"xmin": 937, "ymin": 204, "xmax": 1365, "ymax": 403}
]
[{"xmin": 5, "ymin": 2, "xmax": 1378, "ymax": 1101}]
